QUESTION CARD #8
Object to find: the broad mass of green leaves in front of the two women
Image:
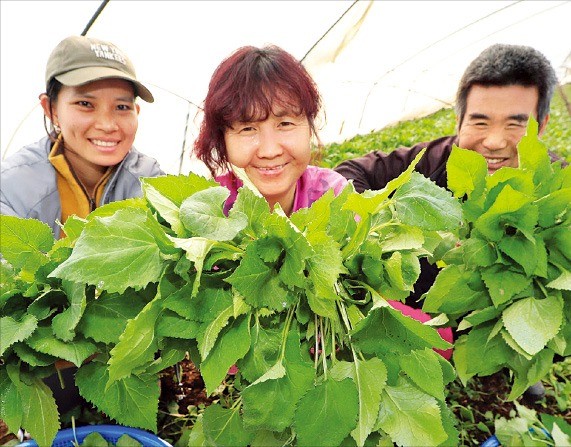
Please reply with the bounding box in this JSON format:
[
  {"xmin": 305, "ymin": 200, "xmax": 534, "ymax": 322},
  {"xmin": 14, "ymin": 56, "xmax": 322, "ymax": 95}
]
[{"xmin": 0, "ymin": 152, "xmax": 462, "ymax": 446}]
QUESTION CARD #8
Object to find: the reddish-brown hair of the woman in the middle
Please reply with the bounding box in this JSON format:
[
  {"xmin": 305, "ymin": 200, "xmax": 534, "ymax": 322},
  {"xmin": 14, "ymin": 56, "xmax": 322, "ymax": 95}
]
[{"xmin": 194, "ymin": 45, "xmax": 321, "ymax": 175}]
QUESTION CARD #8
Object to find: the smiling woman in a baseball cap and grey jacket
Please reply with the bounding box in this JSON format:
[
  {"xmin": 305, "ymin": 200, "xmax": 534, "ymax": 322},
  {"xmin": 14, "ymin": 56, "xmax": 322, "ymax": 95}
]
[{"xmin": 0, "ymin": 36, "xmax": 163, "ymax": 238}]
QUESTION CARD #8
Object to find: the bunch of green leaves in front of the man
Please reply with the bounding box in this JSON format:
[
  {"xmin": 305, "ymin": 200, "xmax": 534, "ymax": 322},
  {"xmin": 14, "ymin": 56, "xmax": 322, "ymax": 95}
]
[{"xmin": 423, "ymin": 119, "xmax": 571, "ymax": 399}]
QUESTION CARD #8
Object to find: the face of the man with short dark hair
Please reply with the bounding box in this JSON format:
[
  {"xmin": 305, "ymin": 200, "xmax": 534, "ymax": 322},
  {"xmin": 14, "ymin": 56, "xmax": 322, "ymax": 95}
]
[{"xmin": 458, "ymin": 85, "xmax": 548, "ymax": 174}]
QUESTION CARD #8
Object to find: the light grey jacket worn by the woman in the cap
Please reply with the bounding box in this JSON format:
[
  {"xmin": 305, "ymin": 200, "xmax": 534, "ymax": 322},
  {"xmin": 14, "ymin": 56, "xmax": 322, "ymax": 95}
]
[{"xmin": 0, "ymin": 137, "xmax": 164, "ymax": 239}]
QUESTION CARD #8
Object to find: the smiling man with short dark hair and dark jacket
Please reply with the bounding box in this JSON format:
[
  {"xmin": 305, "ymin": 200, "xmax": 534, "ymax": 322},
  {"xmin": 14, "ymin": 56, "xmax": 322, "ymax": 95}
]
[{"xmin": 335, "ymin": 44, "xmax": 565, "ymax": 192}]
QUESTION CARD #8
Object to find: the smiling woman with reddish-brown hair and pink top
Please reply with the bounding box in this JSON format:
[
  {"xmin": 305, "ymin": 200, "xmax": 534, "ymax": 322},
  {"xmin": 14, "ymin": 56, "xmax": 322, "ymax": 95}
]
[{"xmin": 194, "ymin": 46, "xmax": 347, "ymax": 215}]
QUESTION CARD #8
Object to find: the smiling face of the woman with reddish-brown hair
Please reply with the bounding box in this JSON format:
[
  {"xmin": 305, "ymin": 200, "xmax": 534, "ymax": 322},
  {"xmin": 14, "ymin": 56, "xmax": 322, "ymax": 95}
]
[{"xmin": 224, "ymin": 109, "xmax": 311, "ymax": 214}]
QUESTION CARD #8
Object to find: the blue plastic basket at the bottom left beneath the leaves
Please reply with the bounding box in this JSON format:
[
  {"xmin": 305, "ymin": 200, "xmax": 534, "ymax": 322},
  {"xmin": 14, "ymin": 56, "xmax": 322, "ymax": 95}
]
[{"xmin": 18, "ymin": 425, "xmax": 173, "ymax": 447}]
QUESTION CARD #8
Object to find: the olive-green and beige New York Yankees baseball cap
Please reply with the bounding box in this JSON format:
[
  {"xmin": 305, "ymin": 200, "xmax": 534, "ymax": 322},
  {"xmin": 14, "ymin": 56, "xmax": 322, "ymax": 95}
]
[{"xmin": 46, "ymin": 36, "xmax": 155, "ymax": 102}]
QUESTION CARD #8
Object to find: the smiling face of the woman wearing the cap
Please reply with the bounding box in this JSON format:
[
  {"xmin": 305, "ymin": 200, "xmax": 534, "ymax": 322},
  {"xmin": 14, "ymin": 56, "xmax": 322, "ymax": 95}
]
[{"xmin": 42, "ymin": 78, "xmax": 139, "ymax": 171}]
